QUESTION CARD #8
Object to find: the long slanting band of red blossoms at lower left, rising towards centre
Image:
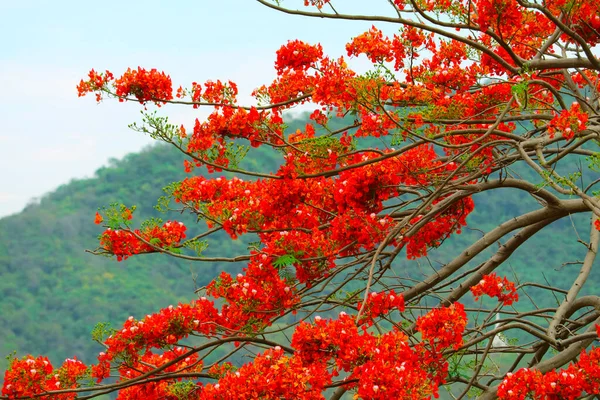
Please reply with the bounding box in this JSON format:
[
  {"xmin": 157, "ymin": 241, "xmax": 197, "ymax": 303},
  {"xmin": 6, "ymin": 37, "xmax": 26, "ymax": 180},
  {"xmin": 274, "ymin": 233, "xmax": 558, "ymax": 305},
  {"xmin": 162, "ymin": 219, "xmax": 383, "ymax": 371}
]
[{"xmin": 88, "ymin": 255, "xmax": 299, "ymax": 379}]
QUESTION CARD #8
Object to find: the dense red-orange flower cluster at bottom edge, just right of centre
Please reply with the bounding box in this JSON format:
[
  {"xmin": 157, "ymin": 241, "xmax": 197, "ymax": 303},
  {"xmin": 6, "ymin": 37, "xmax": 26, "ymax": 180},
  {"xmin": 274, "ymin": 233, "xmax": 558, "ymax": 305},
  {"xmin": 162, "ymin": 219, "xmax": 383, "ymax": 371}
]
[{"xmin": 292, "ymin": 313, "xmax": 458, "ymax": 400}]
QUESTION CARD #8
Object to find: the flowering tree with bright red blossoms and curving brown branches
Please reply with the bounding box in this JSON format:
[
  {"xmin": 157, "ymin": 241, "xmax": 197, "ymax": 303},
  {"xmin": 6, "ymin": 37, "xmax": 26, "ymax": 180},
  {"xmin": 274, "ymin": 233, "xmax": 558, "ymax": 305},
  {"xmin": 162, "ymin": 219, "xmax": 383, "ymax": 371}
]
[{"xmin": 2, "ymin": 0, "xmax": 600, "ymax": 399}]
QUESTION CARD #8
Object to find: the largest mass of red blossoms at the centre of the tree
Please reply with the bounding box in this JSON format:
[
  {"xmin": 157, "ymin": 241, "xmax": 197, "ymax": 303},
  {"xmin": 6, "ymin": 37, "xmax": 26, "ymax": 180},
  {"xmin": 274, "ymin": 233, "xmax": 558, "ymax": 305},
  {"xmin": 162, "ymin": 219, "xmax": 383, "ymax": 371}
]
[{"xmin": 168, "ymin": 142, "xmax": 473, "ymax": 290}]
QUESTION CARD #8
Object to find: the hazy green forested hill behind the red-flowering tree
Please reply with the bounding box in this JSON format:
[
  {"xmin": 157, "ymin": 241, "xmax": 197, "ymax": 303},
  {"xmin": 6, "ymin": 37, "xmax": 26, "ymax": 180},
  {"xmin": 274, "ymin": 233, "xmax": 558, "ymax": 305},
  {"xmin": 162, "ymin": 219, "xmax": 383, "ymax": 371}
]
[{"xmin": 0, "ymin": 115, "xmax": 600, "ymax": 370}]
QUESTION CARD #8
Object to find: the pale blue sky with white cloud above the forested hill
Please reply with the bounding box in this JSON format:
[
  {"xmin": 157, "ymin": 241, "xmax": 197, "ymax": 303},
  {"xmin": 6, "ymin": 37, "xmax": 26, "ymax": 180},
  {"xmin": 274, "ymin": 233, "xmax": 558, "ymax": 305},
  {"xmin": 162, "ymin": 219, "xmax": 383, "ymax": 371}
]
[{"xmin": 0, "ymin": 0, "xmax": 389, "ymax": 217}]
